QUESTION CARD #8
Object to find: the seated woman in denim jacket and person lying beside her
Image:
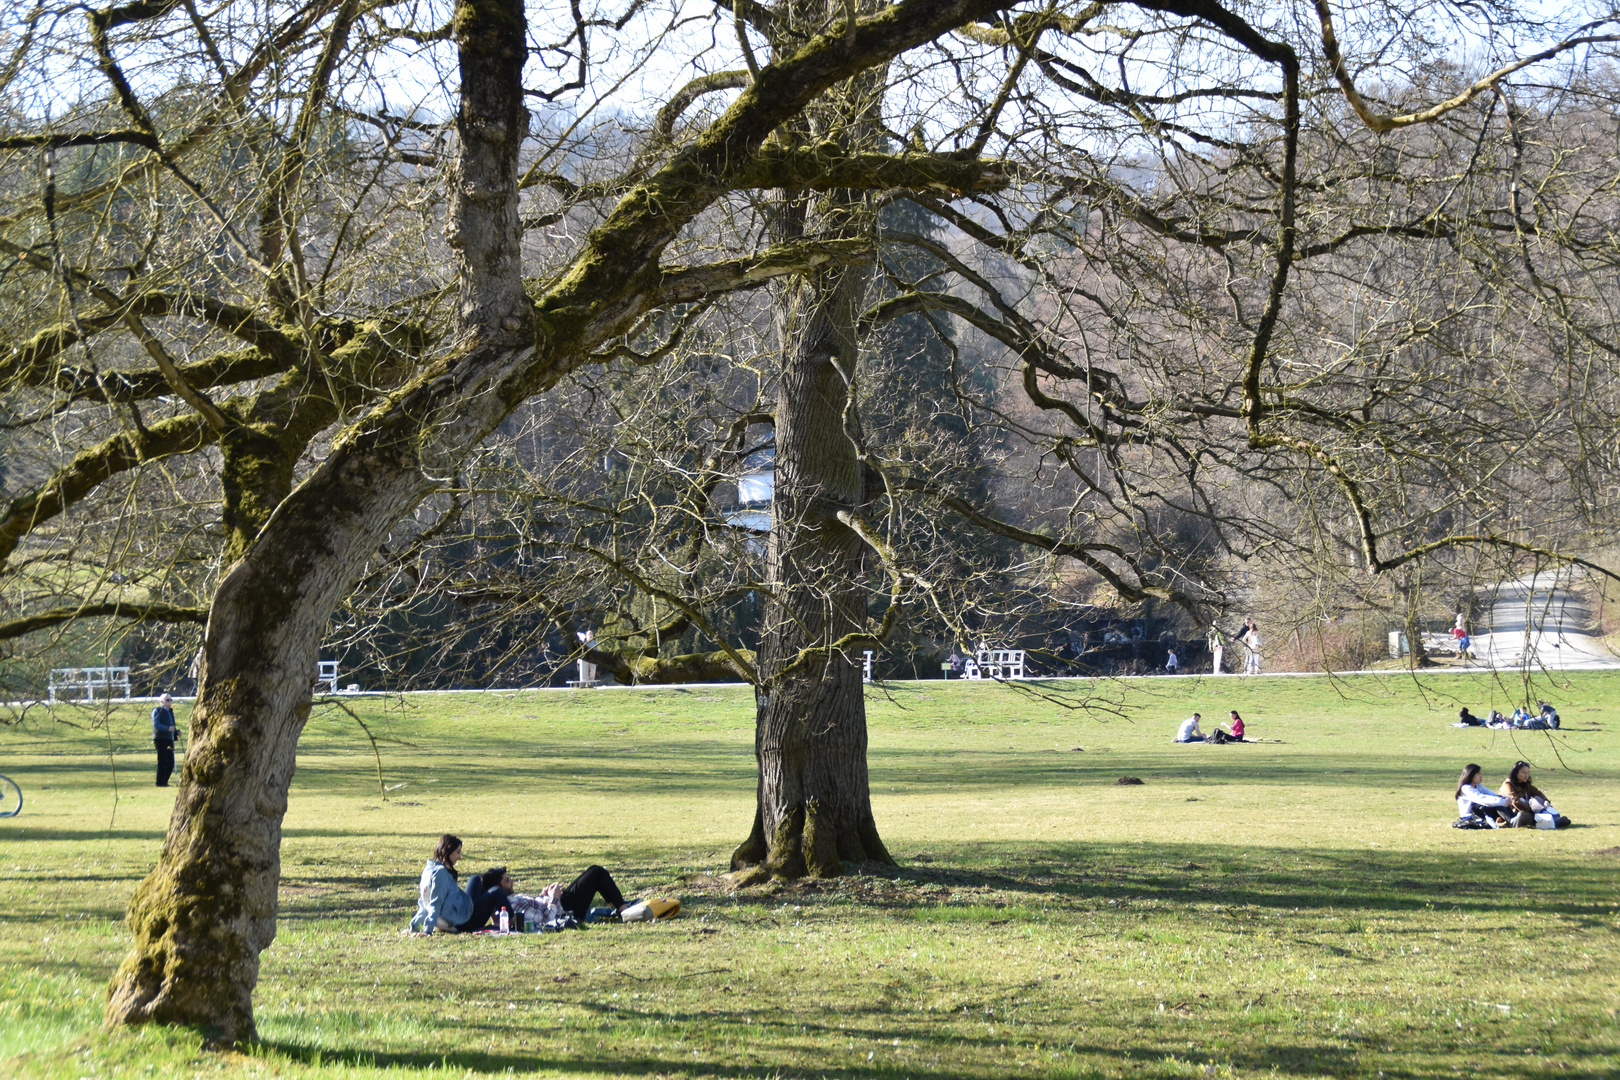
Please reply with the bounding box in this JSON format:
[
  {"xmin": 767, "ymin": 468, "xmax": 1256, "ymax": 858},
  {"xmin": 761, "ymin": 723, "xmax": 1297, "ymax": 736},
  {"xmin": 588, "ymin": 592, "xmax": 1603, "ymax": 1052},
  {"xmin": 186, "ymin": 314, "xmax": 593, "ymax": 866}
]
[{"xmin": 410, "ymin": 832, "xmax": 625, "ymax": 934}]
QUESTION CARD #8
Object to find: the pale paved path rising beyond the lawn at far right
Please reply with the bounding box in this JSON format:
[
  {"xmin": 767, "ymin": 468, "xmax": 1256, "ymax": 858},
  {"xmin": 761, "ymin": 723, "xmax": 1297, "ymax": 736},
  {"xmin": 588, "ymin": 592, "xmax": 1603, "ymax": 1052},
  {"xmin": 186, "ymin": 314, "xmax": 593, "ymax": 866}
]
[{"xmin": 1471, "ymin": 570, "xmax": 1620, "ymax": 670}]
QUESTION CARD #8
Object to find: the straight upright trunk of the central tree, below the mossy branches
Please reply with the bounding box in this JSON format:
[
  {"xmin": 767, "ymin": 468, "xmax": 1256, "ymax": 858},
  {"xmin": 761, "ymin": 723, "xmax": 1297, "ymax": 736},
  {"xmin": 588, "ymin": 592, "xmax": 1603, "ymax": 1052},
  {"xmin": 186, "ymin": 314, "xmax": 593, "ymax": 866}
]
[{"xmin": 731, "ymin": 215, "xmax": 893, "ymax": 882}]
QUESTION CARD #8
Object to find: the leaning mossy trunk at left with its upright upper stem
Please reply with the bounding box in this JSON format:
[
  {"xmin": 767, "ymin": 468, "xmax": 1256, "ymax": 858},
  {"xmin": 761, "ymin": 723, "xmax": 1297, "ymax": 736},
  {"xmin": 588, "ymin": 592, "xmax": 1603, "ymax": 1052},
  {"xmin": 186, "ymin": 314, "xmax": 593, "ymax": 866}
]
[{"xmin": 107, "ymin": 0, "xmax": 535, "ymax": 1041}]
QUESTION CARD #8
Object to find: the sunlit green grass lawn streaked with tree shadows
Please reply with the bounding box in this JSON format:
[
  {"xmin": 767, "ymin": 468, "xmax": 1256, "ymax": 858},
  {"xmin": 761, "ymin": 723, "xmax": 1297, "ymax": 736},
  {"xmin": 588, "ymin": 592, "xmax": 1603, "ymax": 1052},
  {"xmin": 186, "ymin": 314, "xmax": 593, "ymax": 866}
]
[{"xmin": 0, "ymin": 674, "xmax": 1620, "ymax": 1080}]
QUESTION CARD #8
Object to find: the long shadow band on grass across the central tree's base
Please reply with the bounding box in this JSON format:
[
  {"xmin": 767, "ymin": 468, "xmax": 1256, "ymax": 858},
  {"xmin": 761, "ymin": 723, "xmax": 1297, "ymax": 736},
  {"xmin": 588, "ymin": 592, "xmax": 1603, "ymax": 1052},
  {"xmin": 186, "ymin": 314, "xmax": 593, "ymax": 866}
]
[{"xmin": 243, "ymin": 836, "xmax": 1620, "ymax": 933}]
